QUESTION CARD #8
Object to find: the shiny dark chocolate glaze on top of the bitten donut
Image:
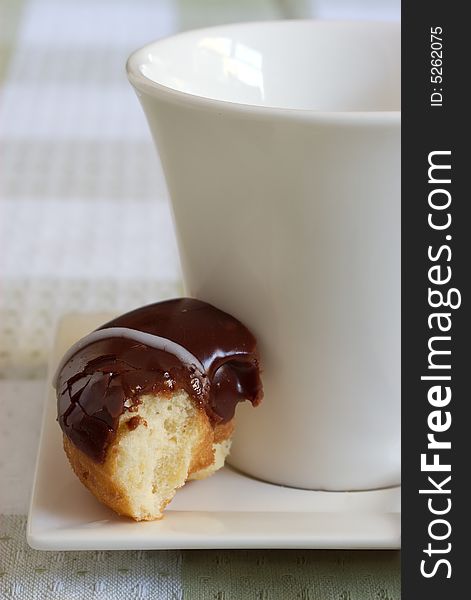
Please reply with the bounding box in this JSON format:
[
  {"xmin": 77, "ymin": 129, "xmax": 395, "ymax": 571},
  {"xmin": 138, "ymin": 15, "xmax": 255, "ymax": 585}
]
[{"xmin": 56, "ymin": 298, "xmax": 263, "ymax": 462}]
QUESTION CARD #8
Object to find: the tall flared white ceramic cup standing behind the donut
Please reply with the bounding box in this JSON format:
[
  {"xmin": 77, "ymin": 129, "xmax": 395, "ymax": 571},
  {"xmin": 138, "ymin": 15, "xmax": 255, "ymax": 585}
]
[{"xmin": 128, "ymin": 21, "xmax": 400, "ymax": 490}]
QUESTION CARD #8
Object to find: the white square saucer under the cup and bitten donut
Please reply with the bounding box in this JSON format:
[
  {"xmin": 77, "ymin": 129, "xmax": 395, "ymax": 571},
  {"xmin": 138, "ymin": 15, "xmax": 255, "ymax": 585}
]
[{"xmin": 27, "ymin": 314, "xmax": 400, "ymax": 550}]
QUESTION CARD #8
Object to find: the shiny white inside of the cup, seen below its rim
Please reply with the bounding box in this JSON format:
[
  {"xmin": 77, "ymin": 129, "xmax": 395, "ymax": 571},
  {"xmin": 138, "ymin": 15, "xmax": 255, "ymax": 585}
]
[{"xmin": 133, "ymin": 21, "xmax": 400, "ymax": 112}]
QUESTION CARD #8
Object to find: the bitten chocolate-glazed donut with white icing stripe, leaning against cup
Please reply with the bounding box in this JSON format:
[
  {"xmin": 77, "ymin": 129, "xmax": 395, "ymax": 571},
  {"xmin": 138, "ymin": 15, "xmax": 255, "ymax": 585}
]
[{"xmin": 55, "ymin": 298, "xmax": 263, "ymax": 520}]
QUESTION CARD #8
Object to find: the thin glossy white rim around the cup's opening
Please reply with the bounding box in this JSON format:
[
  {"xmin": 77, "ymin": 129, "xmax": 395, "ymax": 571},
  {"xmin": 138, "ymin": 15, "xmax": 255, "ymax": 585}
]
[{"xmin": 126, "ymin": 19, "xmax": 401, "ymax": 126}]
